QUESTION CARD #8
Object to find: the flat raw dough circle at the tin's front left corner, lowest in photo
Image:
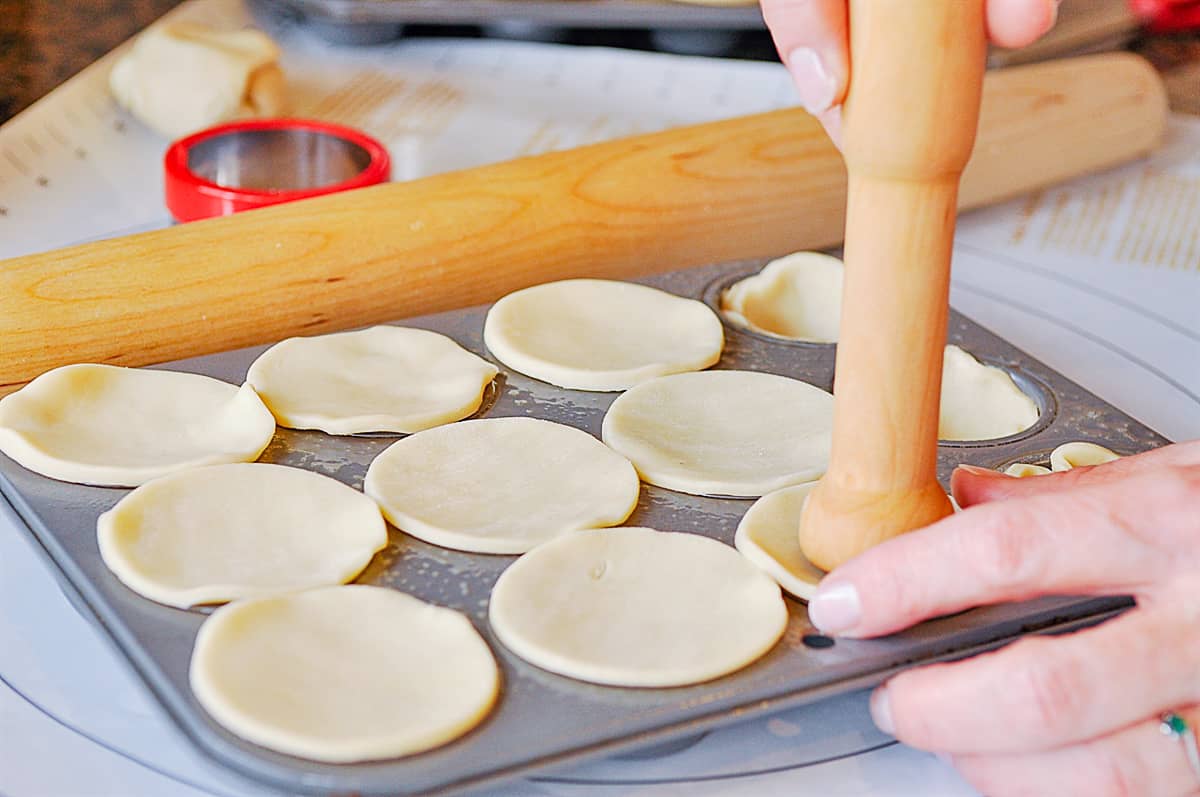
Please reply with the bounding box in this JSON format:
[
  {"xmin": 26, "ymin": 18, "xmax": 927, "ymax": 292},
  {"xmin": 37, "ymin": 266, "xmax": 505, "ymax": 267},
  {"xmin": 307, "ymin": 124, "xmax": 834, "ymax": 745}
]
[{"xmin": 190, "ymin": 586, "xmax": 499, "ymax": 763}]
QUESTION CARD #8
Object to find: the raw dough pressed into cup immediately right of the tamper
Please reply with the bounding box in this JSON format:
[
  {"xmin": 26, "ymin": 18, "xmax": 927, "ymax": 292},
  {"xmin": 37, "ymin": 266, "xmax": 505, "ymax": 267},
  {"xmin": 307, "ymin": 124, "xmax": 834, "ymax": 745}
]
[{"xmin": 937, "ymin": 346, "xmax": 1038, "ymax": 441}]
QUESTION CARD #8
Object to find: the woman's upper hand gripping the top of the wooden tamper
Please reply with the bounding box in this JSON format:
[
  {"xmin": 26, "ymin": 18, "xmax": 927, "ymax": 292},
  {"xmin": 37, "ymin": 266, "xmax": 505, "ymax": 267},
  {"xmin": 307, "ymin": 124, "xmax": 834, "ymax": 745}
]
[{"xmin": 761, "ymin": 0, "xmax": 1058, "ymax": 142}]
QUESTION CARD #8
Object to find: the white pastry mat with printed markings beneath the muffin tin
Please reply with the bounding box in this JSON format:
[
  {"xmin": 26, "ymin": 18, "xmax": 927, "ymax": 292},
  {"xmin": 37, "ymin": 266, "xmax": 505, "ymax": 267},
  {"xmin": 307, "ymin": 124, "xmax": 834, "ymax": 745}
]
[{"xmin": 0, "ymin": 0, "xmax": 1200, "ymax": 797}]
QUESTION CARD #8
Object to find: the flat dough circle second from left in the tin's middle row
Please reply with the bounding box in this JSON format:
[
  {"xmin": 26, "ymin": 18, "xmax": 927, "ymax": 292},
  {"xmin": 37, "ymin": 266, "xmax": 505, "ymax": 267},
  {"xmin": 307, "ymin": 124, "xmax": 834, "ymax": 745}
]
[{"xmin": 362, "ymin": 418, "xmax": 640, "ymax": 553}]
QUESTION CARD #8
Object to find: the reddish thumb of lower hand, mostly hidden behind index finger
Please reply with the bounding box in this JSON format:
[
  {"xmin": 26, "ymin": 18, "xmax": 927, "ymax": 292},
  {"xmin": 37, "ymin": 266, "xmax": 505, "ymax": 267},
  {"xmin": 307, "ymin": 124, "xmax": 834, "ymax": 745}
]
[{"xmin": 950, "ymin": 441, "xmax": 1200, "ymax": 509}]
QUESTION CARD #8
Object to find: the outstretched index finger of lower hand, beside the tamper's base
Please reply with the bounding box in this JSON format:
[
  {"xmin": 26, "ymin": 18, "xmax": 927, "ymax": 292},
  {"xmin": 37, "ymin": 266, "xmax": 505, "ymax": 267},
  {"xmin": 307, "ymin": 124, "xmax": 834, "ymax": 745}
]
[{"xmin": 809, "ymin": 468, "xmax": 1200, "ymax": 637}]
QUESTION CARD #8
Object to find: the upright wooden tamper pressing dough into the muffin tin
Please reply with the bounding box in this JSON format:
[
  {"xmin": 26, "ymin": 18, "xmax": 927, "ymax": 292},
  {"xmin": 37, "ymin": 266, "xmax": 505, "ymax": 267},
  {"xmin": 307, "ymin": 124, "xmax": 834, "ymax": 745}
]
[{"xmin": 799, "ymin": 0, "xmax": 988, "ymax": 570}]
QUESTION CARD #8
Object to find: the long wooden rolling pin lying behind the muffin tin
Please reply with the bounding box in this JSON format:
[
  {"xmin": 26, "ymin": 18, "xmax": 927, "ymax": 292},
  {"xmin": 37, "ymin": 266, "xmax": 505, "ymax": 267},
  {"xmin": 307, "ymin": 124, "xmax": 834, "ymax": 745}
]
[{"xmin": 0, "ymin": 55, "xmax": 1166, "ymax": 394}]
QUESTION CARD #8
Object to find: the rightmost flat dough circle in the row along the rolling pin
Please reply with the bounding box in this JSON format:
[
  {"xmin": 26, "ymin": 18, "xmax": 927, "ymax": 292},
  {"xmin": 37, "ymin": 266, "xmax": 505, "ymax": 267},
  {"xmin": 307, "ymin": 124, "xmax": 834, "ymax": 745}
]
[{"xmin": 484, "ymin": 280, "xmax": 725, "ymax": 390}]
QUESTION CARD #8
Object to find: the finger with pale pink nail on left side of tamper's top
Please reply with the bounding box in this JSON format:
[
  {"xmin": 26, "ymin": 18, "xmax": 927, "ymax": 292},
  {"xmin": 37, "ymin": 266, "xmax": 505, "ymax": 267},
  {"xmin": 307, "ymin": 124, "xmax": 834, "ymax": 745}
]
[{"xmin": 762, "ymin": 0, "xmax": 850, "ymax": 121}]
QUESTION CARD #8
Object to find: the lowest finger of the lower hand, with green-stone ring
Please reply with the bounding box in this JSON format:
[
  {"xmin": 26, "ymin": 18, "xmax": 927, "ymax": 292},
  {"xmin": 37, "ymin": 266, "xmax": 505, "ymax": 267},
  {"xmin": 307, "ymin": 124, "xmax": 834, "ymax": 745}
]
[{"xmin": 952, "ymin": 706, "xmax": 1200, "ymax": 797}]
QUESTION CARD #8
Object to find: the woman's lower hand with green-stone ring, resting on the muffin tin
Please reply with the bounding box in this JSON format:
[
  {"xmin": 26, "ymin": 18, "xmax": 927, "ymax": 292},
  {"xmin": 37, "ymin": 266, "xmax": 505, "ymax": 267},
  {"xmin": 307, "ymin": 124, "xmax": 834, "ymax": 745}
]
[{"xmin": 809, "ymin": 441, "xmax": 1200, "ymax": 797}]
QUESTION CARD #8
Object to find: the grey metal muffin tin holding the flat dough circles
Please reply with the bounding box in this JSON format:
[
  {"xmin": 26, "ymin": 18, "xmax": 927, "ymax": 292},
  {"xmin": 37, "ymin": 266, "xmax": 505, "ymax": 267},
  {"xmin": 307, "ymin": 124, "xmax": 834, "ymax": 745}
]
[{"xmin": 0, "ymin": 263, "xmax": 1166, "ymax": 795}]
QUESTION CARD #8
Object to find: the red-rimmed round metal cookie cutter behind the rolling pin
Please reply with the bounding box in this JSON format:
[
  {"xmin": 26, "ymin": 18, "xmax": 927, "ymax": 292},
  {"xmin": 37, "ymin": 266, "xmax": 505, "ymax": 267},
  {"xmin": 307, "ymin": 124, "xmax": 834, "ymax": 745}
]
[{"xmin": 163, "ymin": 119, "xmax": 391, "ymax": 222}]
